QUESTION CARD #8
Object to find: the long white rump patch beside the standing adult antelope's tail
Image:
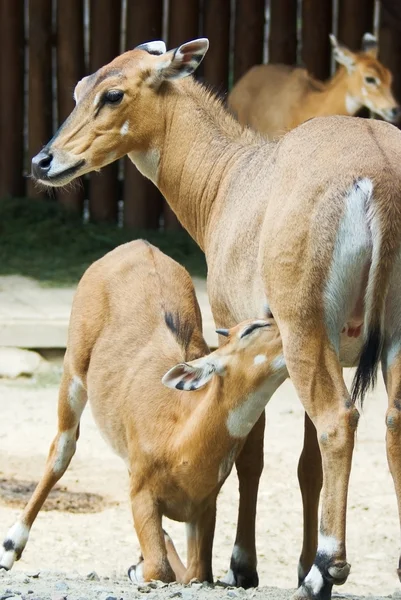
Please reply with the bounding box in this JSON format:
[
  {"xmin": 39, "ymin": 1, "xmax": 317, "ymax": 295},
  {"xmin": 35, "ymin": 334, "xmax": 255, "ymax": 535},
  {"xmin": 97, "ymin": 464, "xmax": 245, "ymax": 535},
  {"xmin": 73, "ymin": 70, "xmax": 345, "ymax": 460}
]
[{"xmin": 324, "ymin": 178, "xmax": 373, "ymax": 352}]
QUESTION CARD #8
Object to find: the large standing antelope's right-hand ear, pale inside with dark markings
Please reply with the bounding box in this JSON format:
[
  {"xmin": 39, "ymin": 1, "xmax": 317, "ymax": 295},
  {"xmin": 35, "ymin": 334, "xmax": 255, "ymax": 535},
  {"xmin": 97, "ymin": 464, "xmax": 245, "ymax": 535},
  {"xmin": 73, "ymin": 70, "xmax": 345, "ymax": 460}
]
[{"xmin": 151, "ymin": 38, "xmax": 209, "ymax": 81}]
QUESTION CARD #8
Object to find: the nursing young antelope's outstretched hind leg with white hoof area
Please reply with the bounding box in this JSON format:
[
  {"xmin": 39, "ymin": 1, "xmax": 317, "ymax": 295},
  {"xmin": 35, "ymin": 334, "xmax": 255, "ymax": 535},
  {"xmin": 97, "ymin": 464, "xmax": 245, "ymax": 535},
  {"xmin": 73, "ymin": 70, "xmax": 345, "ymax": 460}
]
[{"xmin": 0, "ymin": 372, "xmax": 87, "ymax": 569}]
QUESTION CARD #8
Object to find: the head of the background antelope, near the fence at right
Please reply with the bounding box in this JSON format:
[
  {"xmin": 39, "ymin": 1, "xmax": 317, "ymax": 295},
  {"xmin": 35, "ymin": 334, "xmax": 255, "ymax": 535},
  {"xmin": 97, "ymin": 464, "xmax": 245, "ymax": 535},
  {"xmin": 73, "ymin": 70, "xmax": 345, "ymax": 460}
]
[{"xmin": 330, "ymin": 33, "xmax": 401, "ymax": 123}]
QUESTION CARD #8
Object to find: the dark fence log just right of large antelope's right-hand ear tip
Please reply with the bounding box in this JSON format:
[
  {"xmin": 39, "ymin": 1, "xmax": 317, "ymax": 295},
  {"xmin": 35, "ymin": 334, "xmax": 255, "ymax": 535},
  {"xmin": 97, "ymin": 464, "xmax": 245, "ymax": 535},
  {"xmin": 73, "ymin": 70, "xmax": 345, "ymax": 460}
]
[{"xmin": 203, "ymin": 0, "xmax": 230, "ymax": 93}]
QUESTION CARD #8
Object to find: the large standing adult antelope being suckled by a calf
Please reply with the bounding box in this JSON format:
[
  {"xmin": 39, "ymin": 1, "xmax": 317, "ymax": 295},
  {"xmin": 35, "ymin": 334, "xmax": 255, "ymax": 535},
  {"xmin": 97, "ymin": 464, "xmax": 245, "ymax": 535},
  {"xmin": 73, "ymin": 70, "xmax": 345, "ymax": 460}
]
[{"xmin": 26, "ymin": 39, "xmax": 401, "ymax": 599}]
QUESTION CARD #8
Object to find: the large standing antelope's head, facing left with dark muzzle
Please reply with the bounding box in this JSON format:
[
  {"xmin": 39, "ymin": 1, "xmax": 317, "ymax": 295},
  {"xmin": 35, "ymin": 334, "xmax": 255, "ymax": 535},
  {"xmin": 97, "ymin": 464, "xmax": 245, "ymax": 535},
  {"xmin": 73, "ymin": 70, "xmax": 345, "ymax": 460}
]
[{"xmin": 32, "ymin": 38, "xmax": 209, "ymax": 186}]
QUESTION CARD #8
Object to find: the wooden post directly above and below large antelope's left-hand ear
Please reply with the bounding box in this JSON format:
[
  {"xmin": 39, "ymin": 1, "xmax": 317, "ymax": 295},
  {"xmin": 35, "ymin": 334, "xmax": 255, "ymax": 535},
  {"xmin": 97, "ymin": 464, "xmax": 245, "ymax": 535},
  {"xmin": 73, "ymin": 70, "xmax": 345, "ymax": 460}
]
[{"xmin": 124, "ymin": 0, "xmax": 163, "ymax": 229}]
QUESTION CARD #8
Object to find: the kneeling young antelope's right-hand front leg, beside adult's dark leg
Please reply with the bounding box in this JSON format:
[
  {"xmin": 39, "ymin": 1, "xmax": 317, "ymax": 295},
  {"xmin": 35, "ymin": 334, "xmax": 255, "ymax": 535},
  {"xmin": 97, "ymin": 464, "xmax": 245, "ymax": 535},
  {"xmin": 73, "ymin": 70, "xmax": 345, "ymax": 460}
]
[{"xmin": 182, "ymin": 498, "xmax": 217, "ymax": 583}]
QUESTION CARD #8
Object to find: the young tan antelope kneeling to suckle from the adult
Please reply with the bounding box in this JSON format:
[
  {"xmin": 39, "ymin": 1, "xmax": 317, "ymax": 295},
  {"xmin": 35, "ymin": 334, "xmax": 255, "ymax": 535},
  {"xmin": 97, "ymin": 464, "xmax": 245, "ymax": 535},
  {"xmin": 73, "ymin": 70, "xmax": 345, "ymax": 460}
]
[{"xmin": 0, "ymin": 240, "xmax": 287, "ymax": 583}]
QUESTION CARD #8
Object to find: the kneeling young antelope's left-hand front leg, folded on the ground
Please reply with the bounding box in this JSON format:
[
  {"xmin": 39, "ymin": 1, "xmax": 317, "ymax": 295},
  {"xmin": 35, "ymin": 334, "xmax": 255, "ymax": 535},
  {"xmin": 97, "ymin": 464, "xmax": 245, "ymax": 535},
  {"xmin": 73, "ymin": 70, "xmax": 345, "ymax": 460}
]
[{"xmin": 128, "ymin": 490, "xmax": 176, "ymax": 583}]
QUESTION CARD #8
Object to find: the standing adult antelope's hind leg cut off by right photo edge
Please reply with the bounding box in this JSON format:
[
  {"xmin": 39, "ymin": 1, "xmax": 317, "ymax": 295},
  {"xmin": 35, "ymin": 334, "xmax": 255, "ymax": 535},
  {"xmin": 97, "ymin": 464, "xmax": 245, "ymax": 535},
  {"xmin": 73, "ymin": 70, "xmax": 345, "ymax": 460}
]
[{"xmin": 382, "ymin": 347, "xmax": 401, "ymax": 581}]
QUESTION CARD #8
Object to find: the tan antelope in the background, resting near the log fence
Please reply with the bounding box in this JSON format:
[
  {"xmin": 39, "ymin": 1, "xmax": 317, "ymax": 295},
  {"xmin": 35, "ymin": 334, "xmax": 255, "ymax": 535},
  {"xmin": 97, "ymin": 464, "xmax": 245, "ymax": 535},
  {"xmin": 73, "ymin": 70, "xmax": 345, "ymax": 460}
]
[{"xmin": 228, "ymin": 33, "xmax": 400, "ymax": 139}]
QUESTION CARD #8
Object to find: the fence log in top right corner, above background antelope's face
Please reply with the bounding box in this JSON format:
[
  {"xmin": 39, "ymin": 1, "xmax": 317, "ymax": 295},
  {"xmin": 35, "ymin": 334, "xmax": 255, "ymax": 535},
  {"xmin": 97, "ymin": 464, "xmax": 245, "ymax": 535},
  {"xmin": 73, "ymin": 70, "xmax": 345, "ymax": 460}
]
[{"xmin": 379, "ymin": 0, "xmax": 401, "ymax": 110}]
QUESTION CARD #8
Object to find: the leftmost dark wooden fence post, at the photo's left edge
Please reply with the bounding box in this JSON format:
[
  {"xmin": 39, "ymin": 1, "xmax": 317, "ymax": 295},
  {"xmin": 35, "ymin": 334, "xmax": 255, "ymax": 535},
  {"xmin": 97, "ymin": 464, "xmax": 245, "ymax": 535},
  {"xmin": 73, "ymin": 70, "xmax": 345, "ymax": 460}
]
[{"xmin": 0, "ymin": 0, "xmax": 25, "ymax": 200}]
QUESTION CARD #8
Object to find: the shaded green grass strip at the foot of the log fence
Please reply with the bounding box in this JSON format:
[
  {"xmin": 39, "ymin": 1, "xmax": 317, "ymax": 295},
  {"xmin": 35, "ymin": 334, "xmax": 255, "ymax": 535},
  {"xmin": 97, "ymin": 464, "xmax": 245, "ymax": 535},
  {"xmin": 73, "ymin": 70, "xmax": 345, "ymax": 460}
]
[{"xmin": 0, "ymin": 198, "xmax": 206, "ymax": 286}]
